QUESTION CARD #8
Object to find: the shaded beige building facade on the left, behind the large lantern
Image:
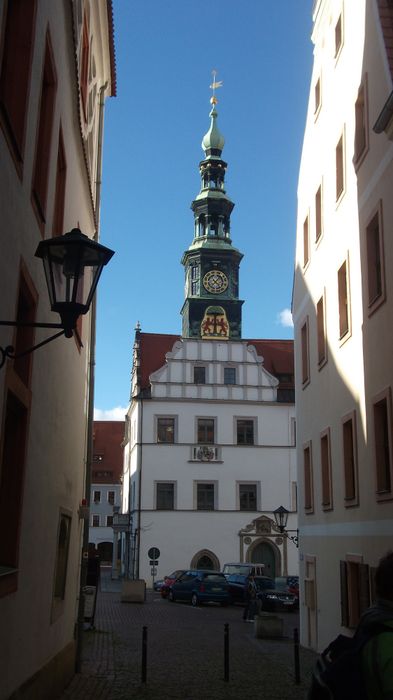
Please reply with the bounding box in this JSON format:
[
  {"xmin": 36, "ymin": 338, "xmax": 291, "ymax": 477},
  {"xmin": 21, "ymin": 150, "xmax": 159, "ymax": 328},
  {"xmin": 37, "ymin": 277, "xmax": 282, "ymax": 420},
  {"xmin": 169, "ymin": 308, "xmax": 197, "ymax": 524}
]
[{"xmin": 0, "ymin": 0, "xmax": 116, "ymax": 700}]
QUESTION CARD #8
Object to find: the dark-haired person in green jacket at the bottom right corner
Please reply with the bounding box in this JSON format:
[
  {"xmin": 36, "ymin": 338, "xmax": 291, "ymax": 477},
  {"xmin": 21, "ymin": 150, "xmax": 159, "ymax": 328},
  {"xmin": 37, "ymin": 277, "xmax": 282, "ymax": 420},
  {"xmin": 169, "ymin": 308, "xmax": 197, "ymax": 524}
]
[{"xmin": 358, "ymin": 552, "xmax": 393, "ymax": 700}]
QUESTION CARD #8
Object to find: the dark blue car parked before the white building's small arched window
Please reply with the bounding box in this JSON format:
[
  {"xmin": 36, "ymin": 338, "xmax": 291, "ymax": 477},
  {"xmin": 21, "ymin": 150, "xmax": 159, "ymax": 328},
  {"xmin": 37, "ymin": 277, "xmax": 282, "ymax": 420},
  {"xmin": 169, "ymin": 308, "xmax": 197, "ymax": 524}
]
[{"xmin": 169, "ymin": 569, "xmax": 230, "ymax": 606}]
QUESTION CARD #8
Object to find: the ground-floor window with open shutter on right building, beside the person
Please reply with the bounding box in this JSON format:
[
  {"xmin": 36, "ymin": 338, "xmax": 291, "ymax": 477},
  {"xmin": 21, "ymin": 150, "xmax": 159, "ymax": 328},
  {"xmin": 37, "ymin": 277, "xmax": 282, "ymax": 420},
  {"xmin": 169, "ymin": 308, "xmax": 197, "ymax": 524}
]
[{"xmin": 340, "ymin": 555, "xmax": 370, "ymax": 629}]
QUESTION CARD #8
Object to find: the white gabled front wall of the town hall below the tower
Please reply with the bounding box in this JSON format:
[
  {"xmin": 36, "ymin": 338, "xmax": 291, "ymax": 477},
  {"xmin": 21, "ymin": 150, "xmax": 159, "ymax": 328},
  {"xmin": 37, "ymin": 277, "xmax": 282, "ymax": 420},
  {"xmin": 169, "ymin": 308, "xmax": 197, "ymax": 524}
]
[{"xmin": 123, "ymin": 333, "xmax": 298, "ymax": 586}]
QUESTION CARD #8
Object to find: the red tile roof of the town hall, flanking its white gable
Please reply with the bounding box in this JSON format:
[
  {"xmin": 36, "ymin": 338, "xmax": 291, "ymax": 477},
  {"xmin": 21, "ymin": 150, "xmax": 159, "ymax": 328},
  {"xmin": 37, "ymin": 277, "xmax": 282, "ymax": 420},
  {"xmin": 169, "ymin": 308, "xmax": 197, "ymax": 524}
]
[{"xmin": 139, "ymin": 333, "xmax": 294, "ymax": 389}]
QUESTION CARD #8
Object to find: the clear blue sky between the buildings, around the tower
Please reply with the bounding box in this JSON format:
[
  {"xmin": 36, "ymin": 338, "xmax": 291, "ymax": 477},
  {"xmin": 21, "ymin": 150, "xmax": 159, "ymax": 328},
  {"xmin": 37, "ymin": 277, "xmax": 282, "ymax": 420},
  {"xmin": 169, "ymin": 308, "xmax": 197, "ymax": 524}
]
[{"xmin": 95, "ymin": 0, "xmax": 312, "ymax": 419}]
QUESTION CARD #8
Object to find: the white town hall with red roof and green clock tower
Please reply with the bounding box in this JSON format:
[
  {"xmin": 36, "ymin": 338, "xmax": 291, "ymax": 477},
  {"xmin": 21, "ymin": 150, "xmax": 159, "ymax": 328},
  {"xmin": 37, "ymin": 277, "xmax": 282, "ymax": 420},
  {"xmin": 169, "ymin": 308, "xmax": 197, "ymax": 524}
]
[{"xmin": 122, "ymin": 96, "xmax": 298, "ymax": 586}]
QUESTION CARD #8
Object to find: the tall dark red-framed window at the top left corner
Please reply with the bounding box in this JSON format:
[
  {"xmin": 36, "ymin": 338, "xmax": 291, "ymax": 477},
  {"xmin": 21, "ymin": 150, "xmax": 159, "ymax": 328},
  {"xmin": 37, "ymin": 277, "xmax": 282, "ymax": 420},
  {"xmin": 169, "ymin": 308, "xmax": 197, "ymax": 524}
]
[{"xmin": 0, "ymin": 0, "xmax": 36, "ymax": 168}]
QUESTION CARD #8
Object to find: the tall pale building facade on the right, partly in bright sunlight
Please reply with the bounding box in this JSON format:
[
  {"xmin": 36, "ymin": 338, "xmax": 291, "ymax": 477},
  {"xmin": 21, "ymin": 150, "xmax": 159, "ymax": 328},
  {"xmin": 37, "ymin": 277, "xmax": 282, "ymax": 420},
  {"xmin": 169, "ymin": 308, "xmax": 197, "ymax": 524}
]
[{"xmin": 293, "ymin": 0, "xmax": 393, "ymax": 649}]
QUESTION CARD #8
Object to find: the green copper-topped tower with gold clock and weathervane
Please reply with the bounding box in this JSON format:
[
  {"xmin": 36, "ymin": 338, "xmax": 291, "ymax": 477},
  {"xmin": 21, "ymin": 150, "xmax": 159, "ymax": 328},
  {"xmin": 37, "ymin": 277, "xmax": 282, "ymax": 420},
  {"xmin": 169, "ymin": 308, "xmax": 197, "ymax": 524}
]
[{"xmin": 181, "ymin": 87, "xmax": 243, "ymax": 340}]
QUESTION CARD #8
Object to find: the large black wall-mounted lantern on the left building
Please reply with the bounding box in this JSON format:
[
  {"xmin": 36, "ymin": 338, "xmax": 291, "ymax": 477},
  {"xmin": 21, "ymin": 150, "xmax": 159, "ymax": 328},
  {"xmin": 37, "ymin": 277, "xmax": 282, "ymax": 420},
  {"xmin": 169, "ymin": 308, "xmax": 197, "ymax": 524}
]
[{"xmin": 0, "ymin": 228, "xmax": 114, "ymax": 369}]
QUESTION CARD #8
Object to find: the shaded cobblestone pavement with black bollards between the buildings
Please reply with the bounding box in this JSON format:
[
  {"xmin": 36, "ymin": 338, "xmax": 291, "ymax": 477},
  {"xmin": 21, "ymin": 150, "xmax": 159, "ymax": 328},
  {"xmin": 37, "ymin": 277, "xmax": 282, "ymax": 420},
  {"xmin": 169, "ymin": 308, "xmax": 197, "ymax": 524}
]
[{"xmin": 59, "ymin": 575, "xmax": 315, "ymax": 700}]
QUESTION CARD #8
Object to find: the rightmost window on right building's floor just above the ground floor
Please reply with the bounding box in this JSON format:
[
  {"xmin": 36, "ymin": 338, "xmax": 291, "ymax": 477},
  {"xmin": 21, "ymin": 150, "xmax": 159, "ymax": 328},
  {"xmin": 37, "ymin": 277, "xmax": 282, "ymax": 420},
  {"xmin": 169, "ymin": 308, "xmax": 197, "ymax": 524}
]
[{"xmin": 373, "ymin": 389, "xmax": 392, "ymax": 500}]
